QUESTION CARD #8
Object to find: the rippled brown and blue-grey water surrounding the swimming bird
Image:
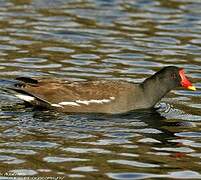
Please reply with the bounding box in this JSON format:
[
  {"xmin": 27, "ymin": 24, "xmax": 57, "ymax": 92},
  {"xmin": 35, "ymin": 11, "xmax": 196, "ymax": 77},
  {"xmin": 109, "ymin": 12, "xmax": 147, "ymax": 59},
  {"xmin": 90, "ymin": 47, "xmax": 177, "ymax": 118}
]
[{"xmin": 0, "ymin": 0, "xmax": 201, "ymax": 179}]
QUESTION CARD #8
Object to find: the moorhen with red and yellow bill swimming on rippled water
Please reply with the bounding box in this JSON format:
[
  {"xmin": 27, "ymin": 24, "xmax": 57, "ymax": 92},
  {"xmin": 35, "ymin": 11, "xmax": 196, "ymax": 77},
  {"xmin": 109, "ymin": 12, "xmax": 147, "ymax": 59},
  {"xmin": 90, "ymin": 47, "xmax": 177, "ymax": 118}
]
[{"xmin": 10, "ymin": 66, "xmax": 196, "ymax": 114}]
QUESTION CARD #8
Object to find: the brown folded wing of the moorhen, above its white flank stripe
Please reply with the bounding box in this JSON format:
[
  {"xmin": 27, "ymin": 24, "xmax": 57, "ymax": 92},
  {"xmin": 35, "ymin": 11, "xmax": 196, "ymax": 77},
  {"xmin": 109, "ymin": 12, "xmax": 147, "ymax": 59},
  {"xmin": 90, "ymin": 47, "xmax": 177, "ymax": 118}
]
[{"xmin": 22, "ymin": 80, "xmax": 124, "ymax": 104}]
